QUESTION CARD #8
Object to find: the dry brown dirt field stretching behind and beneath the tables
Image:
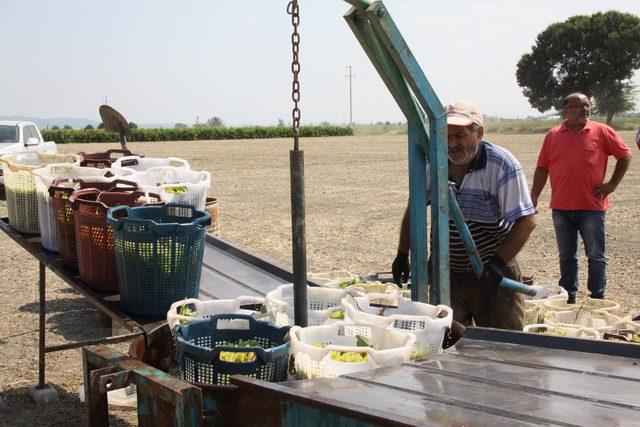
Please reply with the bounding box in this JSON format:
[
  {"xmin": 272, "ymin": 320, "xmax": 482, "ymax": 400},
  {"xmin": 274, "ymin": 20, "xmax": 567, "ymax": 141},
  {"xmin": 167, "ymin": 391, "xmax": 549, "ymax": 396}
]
[{"xmin": 0, "ymin": 132, "xmax": 640, "ymax": 426}]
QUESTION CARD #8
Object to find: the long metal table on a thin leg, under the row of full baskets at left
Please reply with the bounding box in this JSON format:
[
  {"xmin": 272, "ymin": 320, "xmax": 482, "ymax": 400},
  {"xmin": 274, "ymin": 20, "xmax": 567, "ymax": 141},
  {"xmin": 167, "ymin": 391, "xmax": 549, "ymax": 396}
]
[{"xmin": 0, "ymin": 218, "xmax": 317, "ymax": 400}]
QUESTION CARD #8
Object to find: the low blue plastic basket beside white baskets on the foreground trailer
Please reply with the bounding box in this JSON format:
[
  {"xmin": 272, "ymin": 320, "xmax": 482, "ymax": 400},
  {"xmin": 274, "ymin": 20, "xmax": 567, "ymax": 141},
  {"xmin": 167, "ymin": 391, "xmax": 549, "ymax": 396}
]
[{"xmin": 173, "ymin": 314, "xmax": 289, "ymax": 385}]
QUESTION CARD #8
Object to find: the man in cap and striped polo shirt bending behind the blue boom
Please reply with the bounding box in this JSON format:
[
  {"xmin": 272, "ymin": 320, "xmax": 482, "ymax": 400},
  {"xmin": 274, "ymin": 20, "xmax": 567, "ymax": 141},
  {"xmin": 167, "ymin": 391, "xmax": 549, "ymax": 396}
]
[{"xmin": 392, "ymin": 101, "xmax": 535, "ymax": 330}]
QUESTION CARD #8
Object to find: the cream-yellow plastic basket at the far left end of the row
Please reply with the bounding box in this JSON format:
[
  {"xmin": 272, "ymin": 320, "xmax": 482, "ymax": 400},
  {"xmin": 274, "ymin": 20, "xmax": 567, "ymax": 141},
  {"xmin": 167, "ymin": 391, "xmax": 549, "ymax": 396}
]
[{"xmin": 0, "ymin": 151, "xmax": 80, "ymax": 234}]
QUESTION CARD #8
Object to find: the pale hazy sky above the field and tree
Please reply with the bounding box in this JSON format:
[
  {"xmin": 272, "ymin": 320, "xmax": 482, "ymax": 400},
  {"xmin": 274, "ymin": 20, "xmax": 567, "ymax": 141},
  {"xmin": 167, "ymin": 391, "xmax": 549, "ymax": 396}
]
[{"xmin": 0, "ymin": 0, "xmax": 640, "ymax": 125}]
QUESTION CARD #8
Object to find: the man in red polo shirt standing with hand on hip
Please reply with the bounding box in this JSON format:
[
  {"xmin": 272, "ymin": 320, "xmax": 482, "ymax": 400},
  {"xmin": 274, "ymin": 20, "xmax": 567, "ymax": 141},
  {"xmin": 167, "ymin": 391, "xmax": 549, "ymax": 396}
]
[{"xmin": 531, "ymin": 93, "xmax": 631, "ymax": 304}]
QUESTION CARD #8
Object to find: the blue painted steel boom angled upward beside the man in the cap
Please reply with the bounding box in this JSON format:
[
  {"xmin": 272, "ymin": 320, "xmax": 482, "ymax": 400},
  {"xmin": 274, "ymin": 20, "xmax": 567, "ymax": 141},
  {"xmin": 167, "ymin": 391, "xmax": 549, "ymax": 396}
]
[{"xmin": 345, "ymin": 0, "xmax": 535, "ymax": 304}]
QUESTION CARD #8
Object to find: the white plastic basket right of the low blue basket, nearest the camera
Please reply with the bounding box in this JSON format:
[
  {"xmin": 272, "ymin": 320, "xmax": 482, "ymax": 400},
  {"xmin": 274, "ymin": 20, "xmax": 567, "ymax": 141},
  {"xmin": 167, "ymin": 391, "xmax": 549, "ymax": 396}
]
[{"xmin": 289, "ymin": 322, "xmax": 416, "ymax": 379}]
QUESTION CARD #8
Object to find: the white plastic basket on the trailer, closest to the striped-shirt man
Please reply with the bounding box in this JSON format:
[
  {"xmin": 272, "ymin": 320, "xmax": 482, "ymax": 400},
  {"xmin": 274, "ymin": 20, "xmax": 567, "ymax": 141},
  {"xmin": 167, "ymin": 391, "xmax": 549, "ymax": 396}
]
[{"xmin": 342, "ymin": 294, "xmax": 453, "ymax": 359}]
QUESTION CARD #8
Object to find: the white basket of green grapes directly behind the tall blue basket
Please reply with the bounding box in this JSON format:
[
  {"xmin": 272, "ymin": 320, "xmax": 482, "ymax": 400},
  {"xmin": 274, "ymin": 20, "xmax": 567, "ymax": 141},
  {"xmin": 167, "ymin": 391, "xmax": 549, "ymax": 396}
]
[{"xmin": 127, "ymin": 166, "xmax": 211, "ymax": 210}]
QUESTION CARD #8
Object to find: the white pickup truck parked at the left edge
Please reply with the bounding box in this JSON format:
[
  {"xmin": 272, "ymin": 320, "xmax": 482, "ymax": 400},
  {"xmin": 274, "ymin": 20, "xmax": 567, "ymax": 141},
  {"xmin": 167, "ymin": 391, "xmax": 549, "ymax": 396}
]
[{"xmin": 0, "ymin": 120, "xmax": 58, "ymax": 185}]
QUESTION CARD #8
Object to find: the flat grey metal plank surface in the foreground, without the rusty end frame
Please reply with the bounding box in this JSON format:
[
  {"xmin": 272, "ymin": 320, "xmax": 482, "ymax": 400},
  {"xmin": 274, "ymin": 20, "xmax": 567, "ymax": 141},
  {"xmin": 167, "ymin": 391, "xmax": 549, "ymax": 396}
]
[{"xmin": 234, "ymin": 328, "xmax": 640, "ymax": 426}]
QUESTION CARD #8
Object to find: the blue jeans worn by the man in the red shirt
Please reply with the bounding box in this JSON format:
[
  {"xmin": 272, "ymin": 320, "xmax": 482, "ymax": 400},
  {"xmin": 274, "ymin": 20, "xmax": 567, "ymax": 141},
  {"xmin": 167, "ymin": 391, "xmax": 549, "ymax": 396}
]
[{"xmin": 553, "ymin": 209, "xmax": 607, "ymax": 298}]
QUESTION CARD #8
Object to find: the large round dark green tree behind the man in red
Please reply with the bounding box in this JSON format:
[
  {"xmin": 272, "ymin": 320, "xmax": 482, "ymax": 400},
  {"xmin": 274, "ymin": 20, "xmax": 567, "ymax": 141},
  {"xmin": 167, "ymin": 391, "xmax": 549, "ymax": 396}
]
[{"xmin": 516, "ymin": 11, "xmax": 640, "ymax": 124}]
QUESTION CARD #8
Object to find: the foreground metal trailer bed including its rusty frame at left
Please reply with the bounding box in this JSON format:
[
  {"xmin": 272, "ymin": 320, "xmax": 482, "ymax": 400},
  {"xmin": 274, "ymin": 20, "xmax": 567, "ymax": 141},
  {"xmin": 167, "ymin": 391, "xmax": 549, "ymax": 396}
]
[{"xmin": 83, "ymin": 328, "xmax": 640, "ymax": 427}]
